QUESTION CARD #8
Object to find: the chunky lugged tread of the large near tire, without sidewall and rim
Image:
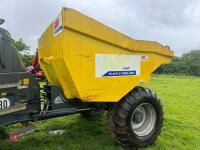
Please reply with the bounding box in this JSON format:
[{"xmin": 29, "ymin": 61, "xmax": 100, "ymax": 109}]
[{"xmin": 107, "ymin": 86, "xmax": 163, "ymax": 148}]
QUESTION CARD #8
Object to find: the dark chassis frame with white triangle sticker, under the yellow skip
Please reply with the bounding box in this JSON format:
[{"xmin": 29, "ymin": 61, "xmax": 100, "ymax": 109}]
[{"xmin": 33, "ymin": 84, "xmax": 107, "ymax": 120}]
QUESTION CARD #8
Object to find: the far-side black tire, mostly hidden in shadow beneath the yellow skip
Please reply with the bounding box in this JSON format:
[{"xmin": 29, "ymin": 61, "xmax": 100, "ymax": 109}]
[{"xmin": 81, "ymin": 110, "xmax": 103, "ymax": 119}]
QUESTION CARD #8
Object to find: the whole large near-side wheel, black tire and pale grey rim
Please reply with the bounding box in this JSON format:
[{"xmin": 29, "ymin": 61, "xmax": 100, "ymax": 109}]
[{"xmin": 108, "ymin": 87, "xmax": 163, "ymax": 148}]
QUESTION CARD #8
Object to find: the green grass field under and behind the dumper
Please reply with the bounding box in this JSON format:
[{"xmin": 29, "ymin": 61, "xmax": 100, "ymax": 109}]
[{"xmin": 1, "ymin": 75, "xmax": 200, "ymax": 150}]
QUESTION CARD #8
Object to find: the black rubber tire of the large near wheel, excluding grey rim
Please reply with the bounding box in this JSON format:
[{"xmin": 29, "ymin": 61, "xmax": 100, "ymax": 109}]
[{"xmin": 107, "ymin": 87, "xmax": 163, "ymax": 148}]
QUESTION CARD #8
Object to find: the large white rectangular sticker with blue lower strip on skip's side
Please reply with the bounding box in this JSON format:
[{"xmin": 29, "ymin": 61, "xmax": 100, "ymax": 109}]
[{"xmin": 96, "ymin": 54, "xmax": 141, "ymax": 77}]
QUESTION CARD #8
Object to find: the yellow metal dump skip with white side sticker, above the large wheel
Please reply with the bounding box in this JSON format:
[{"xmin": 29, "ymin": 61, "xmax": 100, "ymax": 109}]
[{"xmin": 38, "ymin": 8, "xmax": 173, "ymax": 102}]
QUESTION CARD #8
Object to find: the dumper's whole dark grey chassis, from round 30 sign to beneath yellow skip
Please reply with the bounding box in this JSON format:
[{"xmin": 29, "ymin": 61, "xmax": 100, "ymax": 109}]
[{"xmin": 0, "ymin": 72, "xmax": 108, "ymax": 127}]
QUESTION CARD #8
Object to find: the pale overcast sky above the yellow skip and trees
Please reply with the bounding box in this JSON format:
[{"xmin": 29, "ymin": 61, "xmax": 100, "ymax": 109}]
[{"xmin": 0, "ymin": 0, "xmax": 200, "ymax": 56}]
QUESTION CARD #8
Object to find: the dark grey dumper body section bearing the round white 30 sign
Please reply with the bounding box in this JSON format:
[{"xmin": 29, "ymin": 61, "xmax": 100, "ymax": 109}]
[{"xmin": 0, "ymin": 72, "xmax": 41, "ymax": 126}]
